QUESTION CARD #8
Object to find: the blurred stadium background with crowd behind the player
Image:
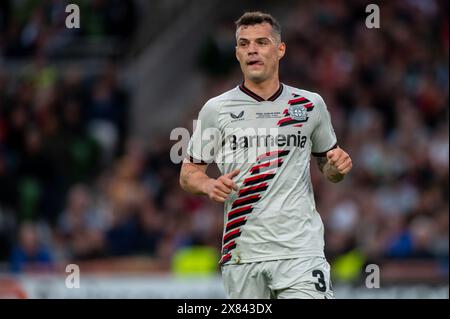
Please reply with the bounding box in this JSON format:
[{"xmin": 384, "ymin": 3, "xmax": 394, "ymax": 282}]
[{"xmin": 0, "ymin": 0, "xmax": 449, "ymax": 298}]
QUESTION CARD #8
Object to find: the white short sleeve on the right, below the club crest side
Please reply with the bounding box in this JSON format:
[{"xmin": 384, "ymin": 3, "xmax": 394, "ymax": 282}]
[{"xmin": 311, "ymin": 94, "xmax": 337, "ymax": 156}]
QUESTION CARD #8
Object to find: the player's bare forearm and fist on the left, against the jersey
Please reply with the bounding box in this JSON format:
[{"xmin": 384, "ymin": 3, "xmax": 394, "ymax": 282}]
[{"xmin": 180, "ymin": 160, "xmax": 239, "ymax": 203}]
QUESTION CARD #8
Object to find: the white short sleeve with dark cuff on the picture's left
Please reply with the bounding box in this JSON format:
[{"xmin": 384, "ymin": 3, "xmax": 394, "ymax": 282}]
[{"xmin": 187, "ymin": 100, "xmax": 220, "ymax": 164}]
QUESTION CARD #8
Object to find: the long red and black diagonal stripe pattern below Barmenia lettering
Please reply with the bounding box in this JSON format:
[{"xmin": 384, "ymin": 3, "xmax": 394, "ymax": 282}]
[{"xmin": 220, "ymin": 150, "xmax": 289, "ymax": 265}]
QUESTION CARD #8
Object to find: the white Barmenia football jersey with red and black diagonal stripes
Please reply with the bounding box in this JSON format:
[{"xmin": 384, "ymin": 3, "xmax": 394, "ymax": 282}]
[{"xmin": 187, "ymin": 84, "xmax": 336, "ymax": 264}]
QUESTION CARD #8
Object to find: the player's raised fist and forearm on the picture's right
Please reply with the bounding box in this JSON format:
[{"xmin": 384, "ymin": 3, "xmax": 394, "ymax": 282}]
[{"xmin": 317, "ymin": 147, "xmax": 353, "ymax": 183}]
